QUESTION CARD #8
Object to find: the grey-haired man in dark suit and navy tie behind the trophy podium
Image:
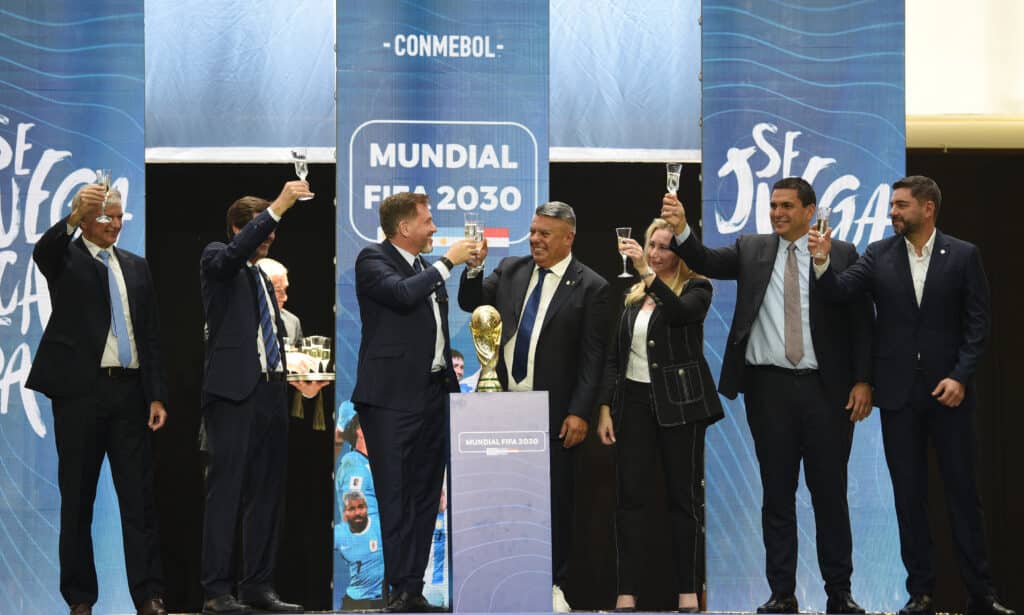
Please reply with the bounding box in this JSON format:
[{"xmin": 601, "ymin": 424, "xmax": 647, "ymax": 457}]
[{"xmin": 459, "ymin": 201, "xmax": 608, "ymax": 612}]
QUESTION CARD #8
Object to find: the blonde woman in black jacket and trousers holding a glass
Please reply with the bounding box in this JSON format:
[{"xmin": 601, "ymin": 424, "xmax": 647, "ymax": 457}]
[{"xmin": 597, "ymin": 218, "xmax": 723, "ymax": 613}]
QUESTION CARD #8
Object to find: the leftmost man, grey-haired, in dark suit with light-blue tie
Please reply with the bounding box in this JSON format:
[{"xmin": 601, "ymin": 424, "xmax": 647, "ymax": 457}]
[{"xmin": 27, "ymin": 185, "xmax": 167, "ymax": 615}]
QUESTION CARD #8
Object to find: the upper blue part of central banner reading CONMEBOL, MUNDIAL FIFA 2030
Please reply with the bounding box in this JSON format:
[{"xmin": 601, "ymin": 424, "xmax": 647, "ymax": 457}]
[{"xmin": 333, "ymin": 0, "xmax": 548, "ymax": 602}]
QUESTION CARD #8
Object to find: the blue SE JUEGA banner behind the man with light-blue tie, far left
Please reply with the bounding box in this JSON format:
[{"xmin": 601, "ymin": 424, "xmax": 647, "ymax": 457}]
[{"xmin": 0, "ymin": 0, "xmax": 145, "ymax": 614}]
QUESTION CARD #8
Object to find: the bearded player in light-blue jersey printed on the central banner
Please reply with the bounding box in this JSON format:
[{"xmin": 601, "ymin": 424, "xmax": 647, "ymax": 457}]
[{"xmin": 334, "ymin": 491, "xmax": 384, "ymax": 611}]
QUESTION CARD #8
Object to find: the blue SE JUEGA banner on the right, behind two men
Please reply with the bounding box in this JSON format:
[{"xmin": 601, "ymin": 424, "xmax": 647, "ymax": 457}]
[{"xmin": 702, "ymin": 0, "xmax": 905, "ymax": 611}]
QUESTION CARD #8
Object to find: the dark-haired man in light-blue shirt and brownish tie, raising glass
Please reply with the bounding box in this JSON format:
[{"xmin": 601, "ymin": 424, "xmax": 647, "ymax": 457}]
[{"xmin": 662, "ymin": 177, "xmax": 871, "ymax": 613}]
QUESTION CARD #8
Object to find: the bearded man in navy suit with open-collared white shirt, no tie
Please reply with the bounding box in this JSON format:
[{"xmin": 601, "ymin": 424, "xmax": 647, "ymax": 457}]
[{"xmin": 811, "ymin": 175, "xmax": 1013, "ymax": 615}]
